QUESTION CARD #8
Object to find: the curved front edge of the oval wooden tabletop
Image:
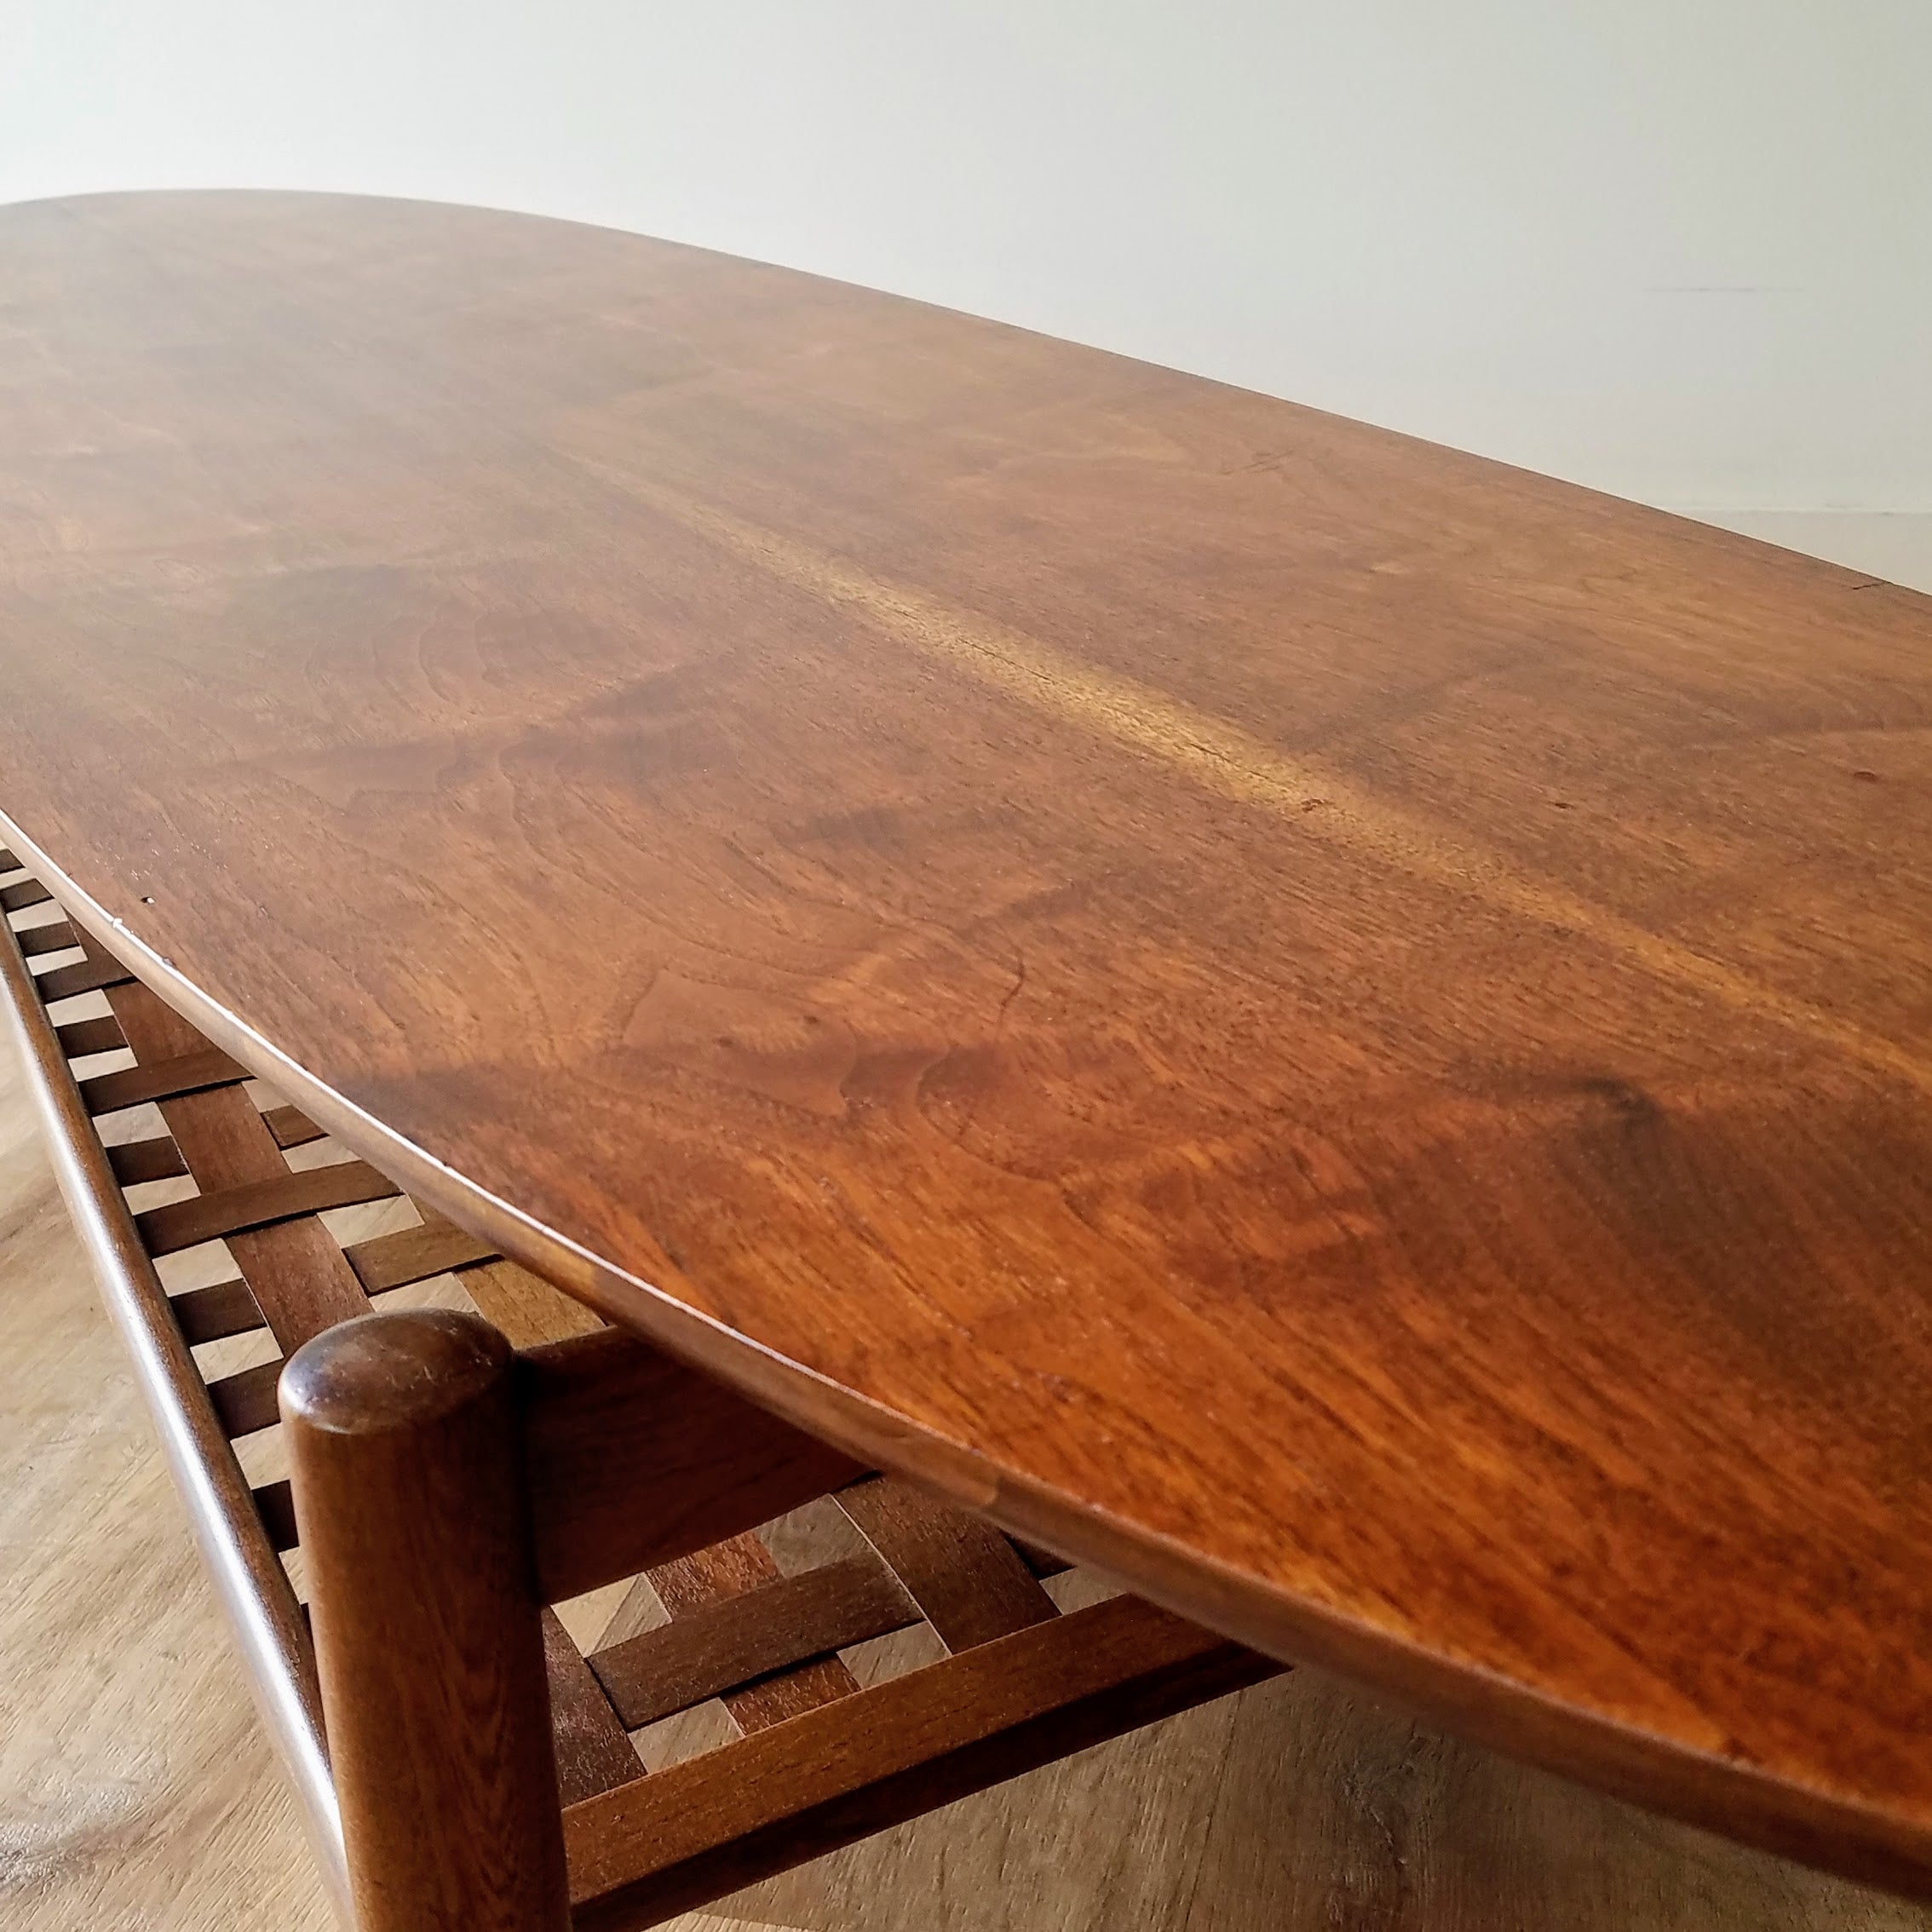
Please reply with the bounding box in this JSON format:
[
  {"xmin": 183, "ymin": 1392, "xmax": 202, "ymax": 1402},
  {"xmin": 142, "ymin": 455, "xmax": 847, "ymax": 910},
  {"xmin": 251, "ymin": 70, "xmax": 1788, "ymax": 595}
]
[{"xmin": 0, "ymin": 809, "xmax": 1932, "ymax": 1899}]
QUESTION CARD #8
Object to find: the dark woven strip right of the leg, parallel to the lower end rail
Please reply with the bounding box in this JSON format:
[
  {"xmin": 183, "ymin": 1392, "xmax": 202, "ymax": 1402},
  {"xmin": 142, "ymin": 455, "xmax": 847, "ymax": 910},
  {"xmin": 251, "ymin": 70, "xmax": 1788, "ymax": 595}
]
[{"xmin": 585, "ymin": 1555, "xmax": 920, "ymax": 1729}]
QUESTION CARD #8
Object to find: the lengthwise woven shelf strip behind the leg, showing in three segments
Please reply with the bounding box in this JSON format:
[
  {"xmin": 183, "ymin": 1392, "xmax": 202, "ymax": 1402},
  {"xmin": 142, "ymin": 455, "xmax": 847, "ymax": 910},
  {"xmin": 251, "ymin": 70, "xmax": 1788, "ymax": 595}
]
[{"xmin": 108, "ymin": 986, "xmax": 369, "ymax": 1354}]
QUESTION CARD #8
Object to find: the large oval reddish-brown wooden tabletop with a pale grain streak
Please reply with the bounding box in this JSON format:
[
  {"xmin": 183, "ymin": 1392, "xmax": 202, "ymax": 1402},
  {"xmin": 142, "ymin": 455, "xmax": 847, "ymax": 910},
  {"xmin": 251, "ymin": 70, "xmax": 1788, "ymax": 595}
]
[{"xmin": 0, "ymin": 195, "xmax": 1932, "ymax": 1889}]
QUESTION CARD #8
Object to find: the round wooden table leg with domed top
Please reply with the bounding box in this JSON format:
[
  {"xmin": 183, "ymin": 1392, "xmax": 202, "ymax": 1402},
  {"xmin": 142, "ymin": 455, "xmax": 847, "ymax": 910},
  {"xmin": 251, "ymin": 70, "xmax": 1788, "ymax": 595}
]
[{"xmin": 282, "ymin": 1310, "xmax": 570, "ymax": 1932}]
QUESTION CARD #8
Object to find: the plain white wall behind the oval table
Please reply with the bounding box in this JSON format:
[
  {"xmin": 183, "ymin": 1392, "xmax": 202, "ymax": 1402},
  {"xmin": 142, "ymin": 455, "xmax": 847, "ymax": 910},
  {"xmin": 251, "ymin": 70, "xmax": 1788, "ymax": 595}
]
[{"xmin": 0, "ymin": 0, "xmax": 1932, "ymax": 512}]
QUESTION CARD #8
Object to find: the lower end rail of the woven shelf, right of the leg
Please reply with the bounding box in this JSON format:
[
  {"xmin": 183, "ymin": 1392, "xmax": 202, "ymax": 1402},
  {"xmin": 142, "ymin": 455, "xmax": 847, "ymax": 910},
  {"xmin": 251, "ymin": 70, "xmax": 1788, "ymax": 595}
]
[{"xmin": 564, "ymin": 1596, "xmax": 1279, "ymax": 1932}]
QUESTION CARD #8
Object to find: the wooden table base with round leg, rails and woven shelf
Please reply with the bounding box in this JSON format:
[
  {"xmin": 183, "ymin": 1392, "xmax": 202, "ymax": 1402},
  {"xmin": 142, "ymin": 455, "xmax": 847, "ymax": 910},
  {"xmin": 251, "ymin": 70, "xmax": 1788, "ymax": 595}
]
[{"xmin": 0, "ymin": 854, "xmax": 1279, "ymax": 1932}]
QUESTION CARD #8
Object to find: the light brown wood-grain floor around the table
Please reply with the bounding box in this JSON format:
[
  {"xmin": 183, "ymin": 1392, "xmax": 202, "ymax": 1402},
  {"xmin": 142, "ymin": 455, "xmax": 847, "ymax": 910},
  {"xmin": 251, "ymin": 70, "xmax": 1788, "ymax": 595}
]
[{"xmin": 0, "ymin": 1012, "xmax": 1932, "ymax": 1932}]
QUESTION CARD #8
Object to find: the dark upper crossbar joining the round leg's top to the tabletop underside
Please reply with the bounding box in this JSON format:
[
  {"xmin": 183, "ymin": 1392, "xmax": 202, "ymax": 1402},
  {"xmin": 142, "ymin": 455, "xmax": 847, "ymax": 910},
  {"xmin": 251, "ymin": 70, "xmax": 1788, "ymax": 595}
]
[{"xmin": 518, "ymin": 1329, "xmax": 865, "ymax": 1603}]
